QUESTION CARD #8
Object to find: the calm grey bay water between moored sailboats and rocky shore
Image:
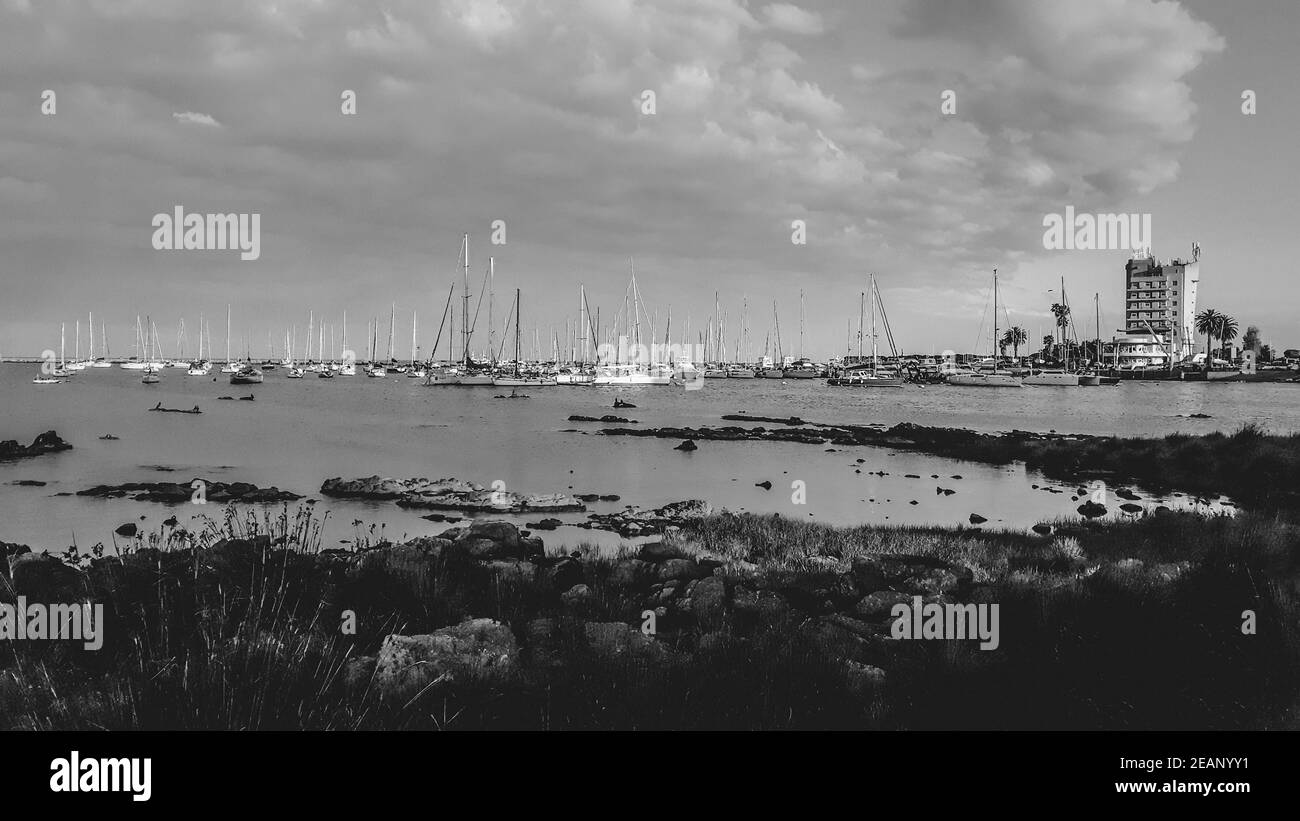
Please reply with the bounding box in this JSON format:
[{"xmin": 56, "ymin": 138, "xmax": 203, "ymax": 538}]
[{"xmin": 0, "ymin": 365, "xmax": 1279, "ymax": 548}]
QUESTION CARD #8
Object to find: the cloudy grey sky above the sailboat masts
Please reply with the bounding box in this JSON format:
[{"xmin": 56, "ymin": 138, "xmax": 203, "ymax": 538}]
[{"xmin": 0, "ymin": 0, "xmax": 1300, "ymax": 357}]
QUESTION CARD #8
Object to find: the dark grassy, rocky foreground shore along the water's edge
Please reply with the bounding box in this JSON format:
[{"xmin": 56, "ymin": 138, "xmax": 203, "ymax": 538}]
[{"xmin": 0, "ymin": 507, "xmax": 1300, "ymax": 729}]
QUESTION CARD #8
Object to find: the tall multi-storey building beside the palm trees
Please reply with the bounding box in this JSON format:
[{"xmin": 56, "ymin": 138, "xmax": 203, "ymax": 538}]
[{"xmin": 1125, "ymin": 243, "xmax": 1201, "ymax": 362}]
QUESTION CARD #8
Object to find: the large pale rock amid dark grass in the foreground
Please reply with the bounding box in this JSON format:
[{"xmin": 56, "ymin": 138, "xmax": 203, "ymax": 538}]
[{"xmin": 374, "ymin": 618, "xmax": 519, "ymax": 701}]
